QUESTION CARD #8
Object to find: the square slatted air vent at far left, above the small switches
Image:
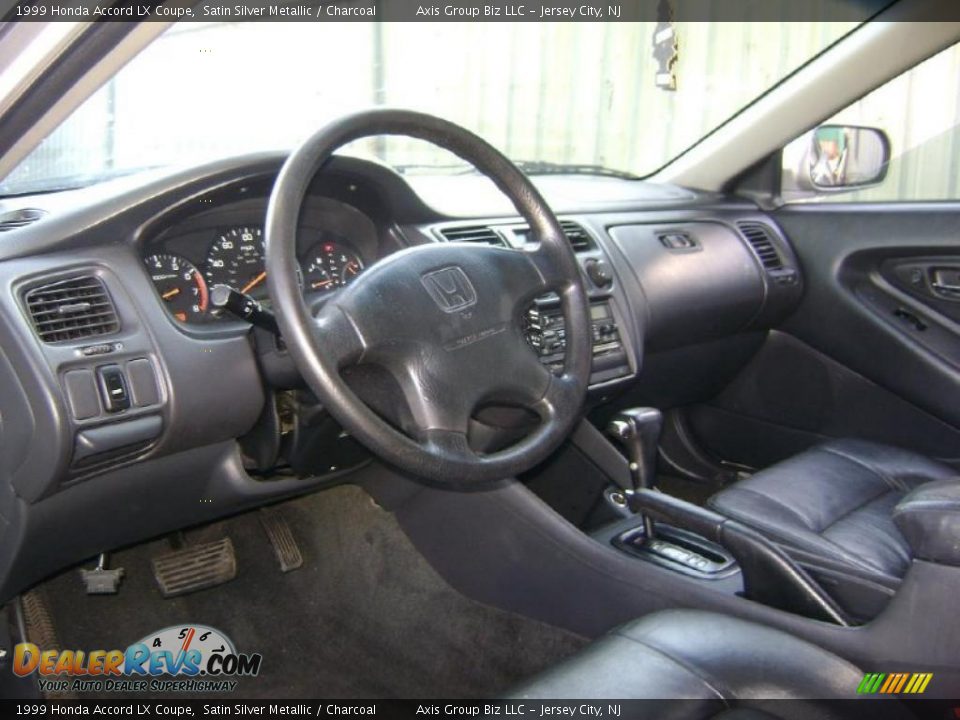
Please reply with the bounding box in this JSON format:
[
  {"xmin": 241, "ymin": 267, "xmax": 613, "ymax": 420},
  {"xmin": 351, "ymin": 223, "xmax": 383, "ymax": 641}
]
[{"xmin": 23, "ymin": 275, "xmax": 120, "ymax": 343}]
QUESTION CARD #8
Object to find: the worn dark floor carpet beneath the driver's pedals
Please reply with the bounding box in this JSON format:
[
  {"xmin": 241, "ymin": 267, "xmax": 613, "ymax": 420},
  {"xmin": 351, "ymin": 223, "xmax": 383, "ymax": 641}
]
[{"xmin": 31, "ymin": 486, "xmax": 586, "ymax": 699}]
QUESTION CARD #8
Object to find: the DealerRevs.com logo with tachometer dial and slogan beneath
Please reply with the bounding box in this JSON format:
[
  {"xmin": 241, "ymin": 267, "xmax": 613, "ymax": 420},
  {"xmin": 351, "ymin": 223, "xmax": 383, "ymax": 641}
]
[{"xmin": 13, "ymin": 625, "xmax": 263, "ymax": 692}]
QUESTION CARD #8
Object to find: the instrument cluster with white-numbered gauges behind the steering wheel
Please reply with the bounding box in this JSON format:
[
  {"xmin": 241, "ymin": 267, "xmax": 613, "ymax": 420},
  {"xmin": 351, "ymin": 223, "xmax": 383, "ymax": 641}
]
[{"xmin": 143, "ymin": 199, "xmax": 378, "ymax": 323}]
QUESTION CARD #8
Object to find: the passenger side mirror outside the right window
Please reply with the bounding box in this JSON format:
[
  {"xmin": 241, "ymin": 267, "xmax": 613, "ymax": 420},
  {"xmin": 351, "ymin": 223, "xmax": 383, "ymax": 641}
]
[{"xmin": 797, "ymin": 125, "xmax": 890, "ymax": 193}]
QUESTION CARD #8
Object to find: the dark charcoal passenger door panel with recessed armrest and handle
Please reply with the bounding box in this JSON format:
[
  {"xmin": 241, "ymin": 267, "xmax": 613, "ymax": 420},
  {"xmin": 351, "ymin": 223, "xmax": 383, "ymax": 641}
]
[{"xmin": 690, "ymin": 203, "xmax": 960, "ymax": 467}]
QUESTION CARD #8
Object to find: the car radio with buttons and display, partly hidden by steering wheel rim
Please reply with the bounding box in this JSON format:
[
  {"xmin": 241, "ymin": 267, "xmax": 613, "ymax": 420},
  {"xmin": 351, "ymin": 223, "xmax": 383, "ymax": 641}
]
[{"xmin": 524, "ymin": 300, "xmax": 630, "ymax": 385}]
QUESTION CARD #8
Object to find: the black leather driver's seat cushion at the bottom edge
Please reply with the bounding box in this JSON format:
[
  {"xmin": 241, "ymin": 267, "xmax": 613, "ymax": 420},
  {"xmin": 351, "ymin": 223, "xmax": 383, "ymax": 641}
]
[{"xmin": 510, "ymin": 610, "xmax": 900, "ymax": 720}]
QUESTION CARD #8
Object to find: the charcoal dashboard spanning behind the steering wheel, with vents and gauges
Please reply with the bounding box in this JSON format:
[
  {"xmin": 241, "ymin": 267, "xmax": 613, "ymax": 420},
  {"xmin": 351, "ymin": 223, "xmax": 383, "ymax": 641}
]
[{"xmin": 0, "ymin": 153, "xmax": 803, "ymax": 596}]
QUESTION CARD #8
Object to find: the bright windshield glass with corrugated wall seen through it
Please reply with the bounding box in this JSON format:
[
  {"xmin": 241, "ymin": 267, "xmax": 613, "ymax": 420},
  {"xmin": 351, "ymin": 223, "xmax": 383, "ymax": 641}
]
[{"xmin": 0, "ymin": 22, "xmax": 855, "ymax": 195}]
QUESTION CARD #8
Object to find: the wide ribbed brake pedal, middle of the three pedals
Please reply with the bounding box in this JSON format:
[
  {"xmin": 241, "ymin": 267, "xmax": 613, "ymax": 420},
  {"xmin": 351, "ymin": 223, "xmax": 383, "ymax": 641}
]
[{"xmin": 151, "ymin": 538, "xmax": 237, "ymax": 598}]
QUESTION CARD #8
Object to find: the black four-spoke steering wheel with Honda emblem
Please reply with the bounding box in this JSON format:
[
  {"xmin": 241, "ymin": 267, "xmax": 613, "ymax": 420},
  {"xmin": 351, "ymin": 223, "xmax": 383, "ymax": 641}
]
[{"xmin": 265, "ymin": 109, "xmax": 591, "ymax": 486}]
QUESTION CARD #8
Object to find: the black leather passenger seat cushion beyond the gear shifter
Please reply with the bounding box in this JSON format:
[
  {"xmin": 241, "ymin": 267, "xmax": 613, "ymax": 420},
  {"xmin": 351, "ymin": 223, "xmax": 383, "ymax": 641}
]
[{"xmin": 708, "ymin": 440, "xmax": 957, "ymax": 579}]
